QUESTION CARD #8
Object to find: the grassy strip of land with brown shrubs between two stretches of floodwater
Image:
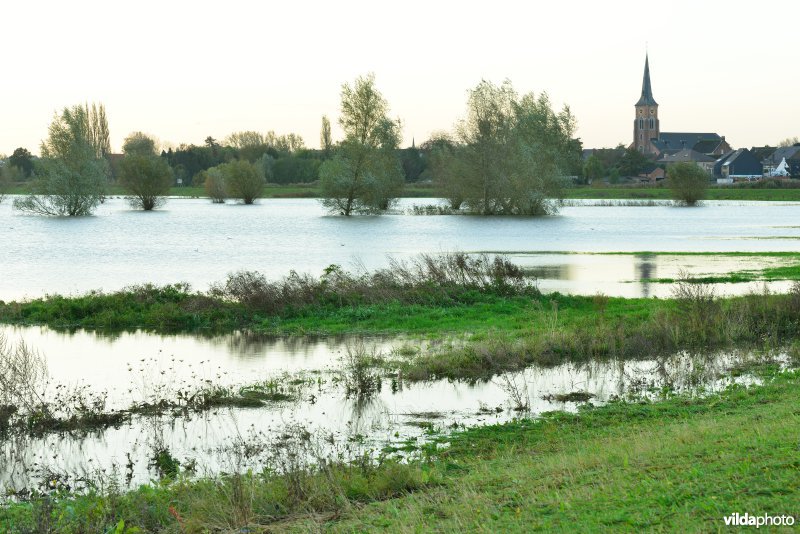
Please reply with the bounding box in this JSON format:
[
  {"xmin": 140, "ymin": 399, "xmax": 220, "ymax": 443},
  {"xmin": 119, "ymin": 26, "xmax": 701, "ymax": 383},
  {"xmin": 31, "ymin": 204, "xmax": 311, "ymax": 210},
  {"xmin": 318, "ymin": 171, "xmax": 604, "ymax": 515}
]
[{"xmin": 6, "ymin": 281, "xmax": 800, "ymax": 386}]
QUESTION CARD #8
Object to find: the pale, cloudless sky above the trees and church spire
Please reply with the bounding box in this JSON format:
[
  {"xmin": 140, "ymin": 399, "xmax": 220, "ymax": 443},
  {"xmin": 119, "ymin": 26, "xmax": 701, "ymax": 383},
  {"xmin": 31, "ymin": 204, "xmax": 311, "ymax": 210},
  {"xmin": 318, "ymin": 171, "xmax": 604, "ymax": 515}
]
[{"xmin": 0, "ymin": 0, "xmax": 800, "ymax": 154}]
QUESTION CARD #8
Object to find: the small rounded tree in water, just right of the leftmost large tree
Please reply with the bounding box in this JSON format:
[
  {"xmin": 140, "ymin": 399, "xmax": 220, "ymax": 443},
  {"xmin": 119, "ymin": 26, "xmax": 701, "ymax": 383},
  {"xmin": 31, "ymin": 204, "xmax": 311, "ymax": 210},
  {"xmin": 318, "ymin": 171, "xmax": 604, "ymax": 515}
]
[{"xmin": 119, "ymin": 132, "xmax": 173, "ymax": 211}]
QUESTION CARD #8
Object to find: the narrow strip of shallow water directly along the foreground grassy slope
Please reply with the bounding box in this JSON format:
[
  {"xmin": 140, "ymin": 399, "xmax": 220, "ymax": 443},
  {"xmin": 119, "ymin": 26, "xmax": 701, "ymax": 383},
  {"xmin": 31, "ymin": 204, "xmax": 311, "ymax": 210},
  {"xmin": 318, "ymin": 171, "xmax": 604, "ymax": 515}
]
[{"xmin": 0, "ymin": 351, "xmax": 786, "ymax": 496}]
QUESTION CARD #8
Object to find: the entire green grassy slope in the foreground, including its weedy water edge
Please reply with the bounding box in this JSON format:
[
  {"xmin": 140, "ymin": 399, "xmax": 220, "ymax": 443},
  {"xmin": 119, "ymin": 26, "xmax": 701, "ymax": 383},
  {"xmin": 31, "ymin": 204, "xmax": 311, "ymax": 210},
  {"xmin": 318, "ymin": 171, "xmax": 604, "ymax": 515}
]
[{"xmin": 0, "ymin": 370, "xmax": 800, "ymax": 532}]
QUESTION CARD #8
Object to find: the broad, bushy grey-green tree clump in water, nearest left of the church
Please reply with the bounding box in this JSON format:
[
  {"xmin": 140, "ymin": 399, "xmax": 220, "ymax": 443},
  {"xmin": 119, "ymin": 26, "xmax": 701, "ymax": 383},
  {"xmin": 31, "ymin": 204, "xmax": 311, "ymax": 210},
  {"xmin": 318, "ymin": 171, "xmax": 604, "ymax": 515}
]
[{"xmin": 436, "ymin": 81, "xmax": 577, "ymax": 215}]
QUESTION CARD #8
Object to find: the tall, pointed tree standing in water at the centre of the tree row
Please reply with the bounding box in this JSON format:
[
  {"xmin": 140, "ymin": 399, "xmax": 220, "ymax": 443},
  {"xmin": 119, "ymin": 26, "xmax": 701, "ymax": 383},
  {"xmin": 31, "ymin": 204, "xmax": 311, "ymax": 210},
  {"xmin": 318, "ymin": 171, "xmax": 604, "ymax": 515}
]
[{"xmin": 320, "ymin": 74, "xmax": 403, "ymax": 215}]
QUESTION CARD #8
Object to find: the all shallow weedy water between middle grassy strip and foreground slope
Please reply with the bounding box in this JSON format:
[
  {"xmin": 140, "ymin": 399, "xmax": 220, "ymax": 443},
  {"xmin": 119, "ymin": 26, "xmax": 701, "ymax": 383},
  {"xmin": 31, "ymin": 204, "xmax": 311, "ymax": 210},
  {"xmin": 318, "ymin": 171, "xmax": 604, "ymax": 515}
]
[{"xmin": 0, "ymin": 327, "xmax": 780, "ymax": 491}]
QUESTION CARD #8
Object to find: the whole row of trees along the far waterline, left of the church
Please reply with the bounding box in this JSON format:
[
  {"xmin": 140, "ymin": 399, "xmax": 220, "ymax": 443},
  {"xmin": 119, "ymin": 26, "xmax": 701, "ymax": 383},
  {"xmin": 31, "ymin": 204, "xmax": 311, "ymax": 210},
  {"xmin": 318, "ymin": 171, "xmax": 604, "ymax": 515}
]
[{"xmin": 0, "ymin": 74, "xmax": 581, "ymax": 216}]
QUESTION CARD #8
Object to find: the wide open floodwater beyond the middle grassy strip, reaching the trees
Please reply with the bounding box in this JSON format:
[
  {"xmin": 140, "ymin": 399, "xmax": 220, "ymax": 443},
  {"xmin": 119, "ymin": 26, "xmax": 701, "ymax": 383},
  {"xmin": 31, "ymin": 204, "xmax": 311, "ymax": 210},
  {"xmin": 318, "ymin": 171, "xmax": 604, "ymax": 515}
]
[{"xmin": 0, "ymin": 198, "xmax": 800, "ymax": 300}]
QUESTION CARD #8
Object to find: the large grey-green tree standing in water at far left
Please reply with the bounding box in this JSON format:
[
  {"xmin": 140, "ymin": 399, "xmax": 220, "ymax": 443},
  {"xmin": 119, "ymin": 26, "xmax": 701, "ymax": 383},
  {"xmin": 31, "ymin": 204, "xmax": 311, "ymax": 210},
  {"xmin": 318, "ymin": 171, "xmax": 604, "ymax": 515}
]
[{"xmin": 14, "ymin": 106, "xmax": 106, "ymax": 217}]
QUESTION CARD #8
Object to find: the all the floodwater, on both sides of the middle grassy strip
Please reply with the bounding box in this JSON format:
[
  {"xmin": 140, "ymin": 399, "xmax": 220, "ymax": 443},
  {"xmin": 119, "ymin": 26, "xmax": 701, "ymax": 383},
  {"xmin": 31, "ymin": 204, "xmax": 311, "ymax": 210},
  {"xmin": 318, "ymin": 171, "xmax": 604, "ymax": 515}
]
[{"xmin": 0, "ymin": 199, "xmax": 800, "ymax": 496}]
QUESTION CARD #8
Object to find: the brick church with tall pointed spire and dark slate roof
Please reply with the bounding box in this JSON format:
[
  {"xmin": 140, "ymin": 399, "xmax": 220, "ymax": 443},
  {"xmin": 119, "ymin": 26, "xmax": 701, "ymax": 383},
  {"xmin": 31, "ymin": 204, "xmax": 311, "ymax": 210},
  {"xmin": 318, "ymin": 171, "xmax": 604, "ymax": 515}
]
[{"xmin": 630, "ymin": 55, "xmax": 732, "ymax": 163}]
